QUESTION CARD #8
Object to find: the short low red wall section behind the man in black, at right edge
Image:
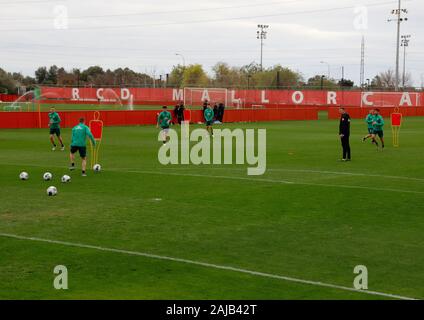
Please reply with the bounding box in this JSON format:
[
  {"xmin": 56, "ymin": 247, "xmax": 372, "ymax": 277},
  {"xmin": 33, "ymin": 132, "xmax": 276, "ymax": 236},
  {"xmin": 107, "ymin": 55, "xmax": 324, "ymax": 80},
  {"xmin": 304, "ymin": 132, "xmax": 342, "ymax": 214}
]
[{"xmin": 328, "ymin": 107, "xmax": 424, "ymax": 119}]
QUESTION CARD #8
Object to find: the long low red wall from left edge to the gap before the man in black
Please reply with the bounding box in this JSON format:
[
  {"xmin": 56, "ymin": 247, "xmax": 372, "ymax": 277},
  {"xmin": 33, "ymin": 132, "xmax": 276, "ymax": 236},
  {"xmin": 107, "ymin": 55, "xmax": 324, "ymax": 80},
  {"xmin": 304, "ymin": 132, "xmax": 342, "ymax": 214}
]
[{"xmin": 0, "ymin": 108, "xmax": 318, "ymax": 129}]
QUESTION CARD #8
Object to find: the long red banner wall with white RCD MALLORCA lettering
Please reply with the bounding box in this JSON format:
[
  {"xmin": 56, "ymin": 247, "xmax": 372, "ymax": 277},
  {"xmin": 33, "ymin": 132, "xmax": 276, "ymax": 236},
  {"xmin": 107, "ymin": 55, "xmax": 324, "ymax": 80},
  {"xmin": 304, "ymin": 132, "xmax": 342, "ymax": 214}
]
[{"xmin": 41, "ymin": 87, "xmax": 424, "ymax": 109}]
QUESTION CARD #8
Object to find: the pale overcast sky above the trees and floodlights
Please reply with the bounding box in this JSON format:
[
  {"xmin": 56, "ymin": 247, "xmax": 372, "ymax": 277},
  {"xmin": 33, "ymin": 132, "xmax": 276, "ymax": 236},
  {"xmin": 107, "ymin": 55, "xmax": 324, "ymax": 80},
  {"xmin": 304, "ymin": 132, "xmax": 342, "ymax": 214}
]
[{"xmin": 0, "ymin": 0, "xmax": 424, "ymax": 86}]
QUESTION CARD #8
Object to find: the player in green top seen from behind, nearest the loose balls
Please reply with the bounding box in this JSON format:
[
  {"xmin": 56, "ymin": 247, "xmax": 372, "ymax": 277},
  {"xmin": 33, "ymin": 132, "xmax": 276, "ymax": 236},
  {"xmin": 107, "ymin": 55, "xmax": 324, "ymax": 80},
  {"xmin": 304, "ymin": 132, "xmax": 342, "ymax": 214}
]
[{"xmin": 69, "ymin": 118, "xmax": 96, "ymax": 177}]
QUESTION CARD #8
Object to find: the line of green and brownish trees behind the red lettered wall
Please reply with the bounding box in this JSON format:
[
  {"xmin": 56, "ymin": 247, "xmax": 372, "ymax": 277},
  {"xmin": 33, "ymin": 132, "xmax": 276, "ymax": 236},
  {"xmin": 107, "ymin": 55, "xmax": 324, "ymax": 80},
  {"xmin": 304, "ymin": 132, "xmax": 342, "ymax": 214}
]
[{"xmin": 0, "ymin": 62, "xmax": 418, "ymax": 93}]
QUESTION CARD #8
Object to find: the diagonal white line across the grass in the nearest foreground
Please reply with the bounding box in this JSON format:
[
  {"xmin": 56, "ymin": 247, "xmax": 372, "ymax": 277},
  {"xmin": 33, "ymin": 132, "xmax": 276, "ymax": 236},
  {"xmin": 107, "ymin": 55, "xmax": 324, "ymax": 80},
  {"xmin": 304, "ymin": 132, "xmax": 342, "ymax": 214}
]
[{"xmin": 0, "ymin": 233, "xmax": 417, "ymax": 300}]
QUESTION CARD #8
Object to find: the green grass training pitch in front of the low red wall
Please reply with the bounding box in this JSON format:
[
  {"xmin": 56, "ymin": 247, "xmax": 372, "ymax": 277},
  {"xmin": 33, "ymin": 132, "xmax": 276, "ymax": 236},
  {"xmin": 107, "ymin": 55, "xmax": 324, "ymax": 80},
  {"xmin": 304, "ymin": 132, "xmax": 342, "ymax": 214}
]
[{"xmin": 0, "ymin": 118, "xmax": 424, "ymax": 299}]
